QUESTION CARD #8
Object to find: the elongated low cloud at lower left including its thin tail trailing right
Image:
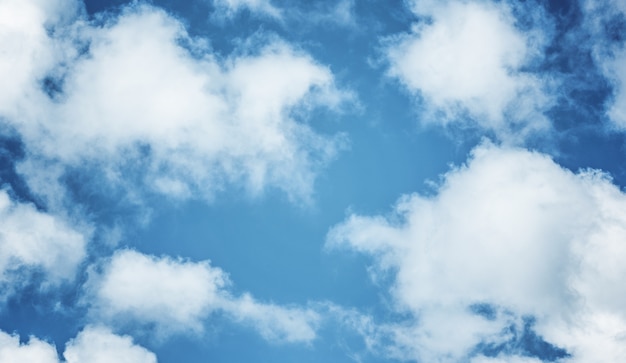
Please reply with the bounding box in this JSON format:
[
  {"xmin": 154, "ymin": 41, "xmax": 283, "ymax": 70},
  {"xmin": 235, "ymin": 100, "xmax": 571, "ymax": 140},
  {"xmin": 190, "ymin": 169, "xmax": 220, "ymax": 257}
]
[{"xmin": 85, "ymin": 250, "xmax": 320, "ymax": 342}]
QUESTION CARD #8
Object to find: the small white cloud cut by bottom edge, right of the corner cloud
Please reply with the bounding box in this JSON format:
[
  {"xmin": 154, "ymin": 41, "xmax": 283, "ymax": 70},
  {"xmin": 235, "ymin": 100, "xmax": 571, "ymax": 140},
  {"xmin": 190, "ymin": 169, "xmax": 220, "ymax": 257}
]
[{"xmin": 63, "ymin": 326, "xmax": 157, "ymax": 363}]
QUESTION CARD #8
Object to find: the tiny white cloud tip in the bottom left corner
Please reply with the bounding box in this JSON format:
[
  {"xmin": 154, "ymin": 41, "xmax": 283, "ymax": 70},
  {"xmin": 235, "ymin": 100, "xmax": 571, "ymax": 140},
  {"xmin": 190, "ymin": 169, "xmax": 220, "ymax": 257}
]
[{"xmin": 0, "ymin": 331, "xmax": 59, "ymax": 363}]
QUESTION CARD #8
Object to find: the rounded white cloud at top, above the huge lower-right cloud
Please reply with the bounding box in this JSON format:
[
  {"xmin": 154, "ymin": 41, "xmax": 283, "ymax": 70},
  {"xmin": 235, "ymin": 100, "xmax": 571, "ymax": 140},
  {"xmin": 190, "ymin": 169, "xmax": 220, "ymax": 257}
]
[{"xmin": 386, "ymin": 1, "xmax": 551, "ymax": 141}]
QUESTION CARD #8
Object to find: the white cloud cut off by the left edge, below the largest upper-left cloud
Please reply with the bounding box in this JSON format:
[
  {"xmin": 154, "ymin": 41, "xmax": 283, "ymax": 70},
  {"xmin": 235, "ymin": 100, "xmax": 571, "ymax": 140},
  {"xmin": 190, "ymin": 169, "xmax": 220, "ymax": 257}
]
[{"xmin": 0, "ymin": 190, "xmax": 89, "ymax": 300}]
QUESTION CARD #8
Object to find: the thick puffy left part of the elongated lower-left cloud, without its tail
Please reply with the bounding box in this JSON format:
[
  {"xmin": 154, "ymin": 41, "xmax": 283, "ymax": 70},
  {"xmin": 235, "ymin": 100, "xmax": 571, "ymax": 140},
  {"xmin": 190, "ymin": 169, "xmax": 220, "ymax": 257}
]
[{"xmin": 87, "ymin": 250, "xmax": 227, "ymax": 333}]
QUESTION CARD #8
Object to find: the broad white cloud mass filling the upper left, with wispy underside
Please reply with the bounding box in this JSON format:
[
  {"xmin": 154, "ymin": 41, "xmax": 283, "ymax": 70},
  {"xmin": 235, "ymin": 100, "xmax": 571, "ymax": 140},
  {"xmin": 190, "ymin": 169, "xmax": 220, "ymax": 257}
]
[{"xmin": 0, "ymin": 1, "xmax": 348, "ymax": 206}]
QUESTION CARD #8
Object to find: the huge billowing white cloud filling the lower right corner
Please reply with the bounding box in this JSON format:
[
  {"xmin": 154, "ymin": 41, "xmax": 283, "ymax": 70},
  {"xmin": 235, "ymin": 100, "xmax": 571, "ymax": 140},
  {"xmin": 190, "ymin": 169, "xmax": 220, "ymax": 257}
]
[{"xmin": 328, "ymin": 145, "xmax": 626, "ymax": 362}]
